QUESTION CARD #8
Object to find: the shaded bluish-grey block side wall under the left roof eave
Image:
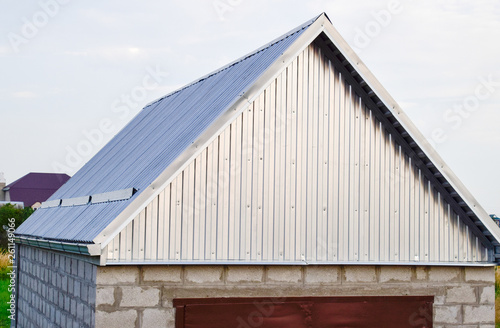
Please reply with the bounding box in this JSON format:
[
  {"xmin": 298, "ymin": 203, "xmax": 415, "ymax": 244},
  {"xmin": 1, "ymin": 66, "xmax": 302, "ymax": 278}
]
[{"xmin": 13, "ymin": 245, "xmax": 97, "ymax": 328}]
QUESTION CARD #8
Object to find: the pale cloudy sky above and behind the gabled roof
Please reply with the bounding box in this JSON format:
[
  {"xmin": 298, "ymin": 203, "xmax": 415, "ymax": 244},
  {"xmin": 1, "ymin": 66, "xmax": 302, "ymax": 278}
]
[{"xmin": 0, "ymin": 0, "xmax": 500, "ymax": 215}]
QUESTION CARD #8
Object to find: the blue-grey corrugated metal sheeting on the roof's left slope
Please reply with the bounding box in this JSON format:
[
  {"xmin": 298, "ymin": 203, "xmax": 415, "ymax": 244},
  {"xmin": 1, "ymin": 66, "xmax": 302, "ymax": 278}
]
[{"xmin": 16, "ymin": 16, "xmax": 319, "ymax": 243}]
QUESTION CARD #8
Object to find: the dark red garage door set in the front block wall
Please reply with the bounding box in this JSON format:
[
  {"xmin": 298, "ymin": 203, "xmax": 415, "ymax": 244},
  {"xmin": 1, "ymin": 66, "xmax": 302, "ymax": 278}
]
[{"xmin": 174, "ymin": 296, "xmax": 434, "ymax": 328}]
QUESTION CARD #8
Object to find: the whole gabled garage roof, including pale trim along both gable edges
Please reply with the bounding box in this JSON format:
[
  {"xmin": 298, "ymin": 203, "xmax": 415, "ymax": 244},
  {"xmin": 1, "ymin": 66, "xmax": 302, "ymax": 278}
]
[{"xmin": 16, "ymin": 14, "xmax": 500, "ymax": 264}]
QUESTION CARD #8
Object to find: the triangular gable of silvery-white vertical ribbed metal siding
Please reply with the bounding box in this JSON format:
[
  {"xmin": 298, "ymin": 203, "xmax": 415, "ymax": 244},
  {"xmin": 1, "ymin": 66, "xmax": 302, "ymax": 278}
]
[{"xmin": 108, "ymin": 45, "xmax": 488, "ymax": 263}]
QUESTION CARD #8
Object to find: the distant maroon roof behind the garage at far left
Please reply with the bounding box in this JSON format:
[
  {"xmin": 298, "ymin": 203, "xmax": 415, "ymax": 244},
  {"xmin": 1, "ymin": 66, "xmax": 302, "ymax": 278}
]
[{"xmin": 5, "ymin": 173, "xmax": 70, "ymax": 207}]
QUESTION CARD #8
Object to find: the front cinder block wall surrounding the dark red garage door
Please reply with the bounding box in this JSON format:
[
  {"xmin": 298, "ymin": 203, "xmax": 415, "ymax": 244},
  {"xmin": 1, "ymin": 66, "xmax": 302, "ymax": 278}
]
[{"xmin": 96, "ymin": 266, "xmax": 495, "ymax": 328}]
